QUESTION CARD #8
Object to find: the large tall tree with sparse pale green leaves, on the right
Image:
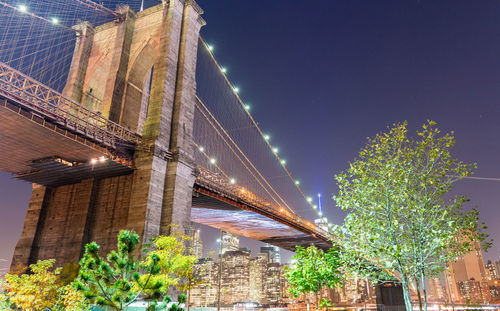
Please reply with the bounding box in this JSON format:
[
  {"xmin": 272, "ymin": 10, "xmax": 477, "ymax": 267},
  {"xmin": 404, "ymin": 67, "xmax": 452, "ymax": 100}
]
[{"xmin": 334, "ymin": 121, "xmax": 489, "ymax": 311}]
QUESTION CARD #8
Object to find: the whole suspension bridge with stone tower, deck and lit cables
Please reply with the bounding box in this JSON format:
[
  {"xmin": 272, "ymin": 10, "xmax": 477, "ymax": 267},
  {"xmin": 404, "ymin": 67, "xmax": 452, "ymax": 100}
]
[{"xmin": 0, "ymin": 0, "xmax": 332, "ymax": 266}]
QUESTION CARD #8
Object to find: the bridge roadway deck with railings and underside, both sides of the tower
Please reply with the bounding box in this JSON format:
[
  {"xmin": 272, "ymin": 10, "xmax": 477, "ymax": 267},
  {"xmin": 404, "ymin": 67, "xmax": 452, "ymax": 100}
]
[{"xmin": 0, "ymin": 63, "xmax": 331, "ymax": 254}]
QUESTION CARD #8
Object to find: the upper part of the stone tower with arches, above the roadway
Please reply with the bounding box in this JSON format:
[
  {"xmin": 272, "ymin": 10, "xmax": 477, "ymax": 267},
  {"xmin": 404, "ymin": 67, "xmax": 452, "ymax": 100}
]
[{"xmin": 63, "ymin": 0, "xmax": 205, "ymax": 154}]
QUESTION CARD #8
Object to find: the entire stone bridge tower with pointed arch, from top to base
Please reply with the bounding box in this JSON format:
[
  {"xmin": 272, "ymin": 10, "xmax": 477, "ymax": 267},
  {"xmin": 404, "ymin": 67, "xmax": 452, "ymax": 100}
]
[{"xmin": 12, "ymin": 0, "xmax": 204, "ymax": 267}]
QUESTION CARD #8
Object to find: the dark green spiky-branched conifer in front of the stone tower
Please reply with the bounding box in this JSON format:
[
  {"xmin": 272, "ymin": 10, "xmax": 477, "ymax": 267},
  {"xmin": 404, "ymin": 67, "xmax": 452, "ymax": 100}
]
[{"xmin": 75, "ymin": 230, "xmax": 163, "ymax": 310}]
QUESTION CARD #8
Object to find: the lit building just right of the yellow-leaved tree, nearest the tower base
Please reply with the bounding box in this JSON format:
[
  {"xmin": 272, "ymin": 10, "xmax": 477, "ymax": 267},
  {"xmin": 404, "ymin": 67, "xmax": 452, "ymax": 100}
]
[{"xmin": 190, "ymin": 258, "xmax": 219, "ymax": 307}]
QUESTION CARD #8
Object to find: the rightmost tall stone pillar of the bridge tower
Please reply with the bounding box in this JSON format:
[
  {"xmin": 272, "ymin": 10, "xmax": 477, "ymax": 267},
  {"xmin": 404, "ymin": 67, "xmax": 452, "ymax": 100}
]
[{"xmin": 160, "ymin": 1, "xmax": 204, "ymax": 234}]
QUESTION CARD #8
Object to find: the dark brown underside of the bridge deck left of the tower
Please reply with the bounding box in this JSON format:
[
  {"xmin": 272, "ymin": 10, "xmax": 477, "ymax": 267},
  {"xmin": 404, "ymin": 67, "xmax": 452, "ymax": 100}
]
[{"xmin": 0, "ymin": 98, "xmax": 131, "ymax": 185}]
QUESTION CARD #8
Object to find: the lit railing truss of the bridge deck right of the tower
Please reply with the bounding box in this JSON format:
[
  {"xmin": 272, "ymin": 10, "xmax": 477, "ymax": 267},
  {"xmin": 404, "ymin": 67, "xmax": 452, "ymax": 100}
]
[{"xmin": 196, "ymin": 167, "xmax": 331, "ymax": 241}]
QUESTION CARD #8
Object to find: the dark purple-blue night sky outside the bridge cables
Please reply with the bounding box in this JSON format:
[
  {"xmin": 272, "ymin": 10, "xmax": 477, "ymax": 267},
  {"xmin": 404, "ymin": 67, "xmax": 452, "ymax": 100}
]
[{"xmin": 0, "ymin": 0, "xmax": 500, "ymax": 268}]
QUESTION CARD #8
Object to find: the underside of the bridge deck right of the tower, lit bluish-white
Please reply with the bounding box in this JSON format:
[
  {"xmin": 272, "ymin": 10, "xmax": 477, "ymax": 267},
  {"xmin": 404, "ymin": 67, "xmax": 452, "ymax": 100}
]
[{"xmin": 191, "ymin": 190, "xmax": 331, "ymax": 251}]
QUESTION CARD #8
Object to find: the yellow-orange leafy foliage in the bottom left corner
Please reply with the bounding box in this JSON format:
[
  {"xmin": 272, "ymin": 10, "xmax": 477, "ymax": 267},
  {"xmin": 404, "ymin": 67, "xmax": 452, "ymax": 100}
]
[{"xmin": 0, "ymin": 259, "xmax": 87, "ymax": 310}]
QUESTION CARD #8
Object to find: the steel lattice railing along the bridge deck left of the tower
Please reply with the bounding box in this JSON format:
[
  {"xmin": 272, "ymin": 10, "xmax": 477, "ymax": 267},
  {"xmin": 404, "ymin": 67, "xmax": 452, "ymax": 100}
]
[{"xmin": 0, "ymin": 62, "xmax": 140, "ymax": 146}]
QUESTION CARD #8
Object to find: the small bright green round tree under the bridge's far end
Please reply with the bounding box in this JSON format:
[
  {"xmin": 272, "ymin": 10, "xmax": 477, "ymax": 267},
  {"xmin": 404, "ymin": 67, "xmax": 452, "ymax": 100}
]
[{"xmin": 285, "ymin": 245, "xmax": 342, "ymax": 309}]
